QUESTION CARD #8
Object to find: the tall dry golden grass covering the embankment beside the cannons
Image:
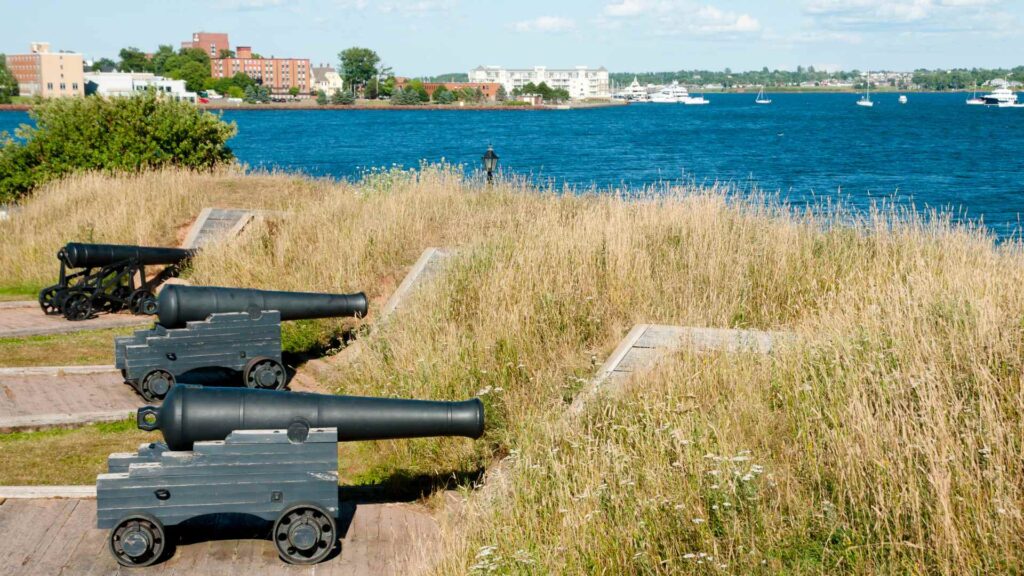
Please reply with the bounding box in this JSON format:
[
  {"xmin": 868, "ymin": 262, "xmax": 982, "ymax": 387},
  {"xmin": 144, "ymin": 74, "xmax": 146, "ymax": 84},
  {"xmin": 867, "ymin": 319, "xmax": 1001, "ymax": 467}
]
[{"xmin": 0, "ymin": 167, "xmax": 1024, "ymax": 574}]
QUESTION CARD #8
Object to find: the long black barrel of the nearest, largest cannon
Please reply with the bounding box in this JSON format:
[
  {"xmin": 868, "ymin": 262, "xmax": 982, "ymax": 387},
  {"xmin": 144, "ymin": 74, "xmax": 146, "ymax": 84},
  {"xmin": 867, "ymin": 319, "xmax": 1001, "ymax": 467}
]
[{"xmin": 137, "ymin": 384, "xmax": 483, "ymax": 450}]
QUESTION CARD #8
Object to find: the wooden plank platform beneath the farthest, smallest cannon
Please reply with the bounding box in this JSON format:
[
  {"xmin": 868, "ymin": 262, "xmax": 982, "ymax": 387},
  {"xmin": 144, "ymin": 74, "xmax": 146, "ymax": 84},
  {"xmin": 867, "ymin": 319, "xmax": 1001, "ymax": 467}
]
[{"xmin": 0, "ymin": 300, "xmax": 153, "ymax": 338}]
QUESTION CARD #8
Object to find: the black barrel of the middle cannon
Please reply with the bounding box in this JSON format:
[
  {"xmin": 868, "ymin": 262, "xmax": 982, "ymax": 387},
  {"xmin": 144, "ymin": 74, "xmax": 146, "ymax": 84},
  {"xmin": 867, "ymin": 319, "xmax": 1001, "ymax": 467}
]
[{"xmin": 157, "ymin": 285, "xmax": 367, "ymax": 328}]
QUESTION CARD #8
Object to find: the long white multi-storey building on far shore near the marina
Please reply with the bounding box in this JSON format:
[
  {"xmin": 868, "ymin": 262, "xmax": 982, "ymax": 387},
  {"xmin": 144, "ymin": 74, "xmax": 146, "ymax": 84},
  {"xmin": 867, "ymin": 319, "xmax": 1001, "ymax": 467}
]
[{"xmin": 469, "ymin": 66, "xmax": 611, "ymax": 99}]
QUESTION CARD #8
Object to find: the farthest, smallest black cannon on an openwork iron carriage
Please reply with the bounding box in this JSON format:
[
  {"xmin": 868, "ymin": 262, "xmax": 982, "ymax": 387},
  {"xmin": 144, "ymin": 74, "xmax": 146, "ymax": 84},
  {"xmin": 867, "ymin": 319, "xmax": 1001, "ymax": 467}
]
[{"xmin": 39, "ymin": 242, "xmax": 195, "ymax": 320}]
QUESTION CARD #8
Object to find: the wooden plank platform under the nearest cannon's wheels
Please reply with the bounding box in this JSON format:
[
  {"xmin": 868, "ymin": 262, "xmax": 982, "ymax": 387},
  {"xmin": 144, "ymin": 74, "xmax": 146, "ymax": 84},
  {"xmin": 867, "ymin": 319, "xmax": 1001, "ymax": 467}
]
[{"xmin": 0, "ymin": 498, "xmax": 440, "ymax": 576}]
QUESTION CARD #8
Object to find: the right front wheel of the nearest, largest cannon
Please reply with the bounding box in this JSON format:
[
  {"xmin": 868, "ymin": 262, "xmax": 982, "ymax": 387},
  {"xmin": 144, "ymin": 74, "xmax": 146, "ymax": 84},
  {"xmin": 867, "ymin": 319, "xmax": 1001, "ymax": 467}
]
[{"xmin": 272, "ymin": 503, "xmax": 338, "ymax": 564}]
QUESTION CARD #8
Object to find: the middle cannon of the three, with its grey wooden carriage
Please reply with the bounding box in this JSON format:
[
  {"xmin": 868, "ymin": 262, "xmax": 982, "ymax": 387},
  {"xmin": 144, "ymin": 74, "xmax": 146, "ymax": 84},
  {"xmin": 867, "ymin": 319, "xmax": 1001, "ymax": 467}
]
[{"xmin": 114, "ymin": 286, "xmax": 367, "ymax": 401}]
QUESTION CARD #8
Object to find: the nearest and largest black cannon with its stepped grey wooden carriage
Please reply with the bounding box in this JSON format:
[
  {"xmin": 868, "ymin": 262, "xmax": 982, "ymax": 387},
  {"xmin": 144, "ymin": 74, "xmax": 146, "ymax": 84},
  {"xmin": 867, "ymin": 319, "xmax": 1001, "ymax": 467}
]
[{"xmin": 96, "ymin": 385, "xmax": 484, "ymax": 567}]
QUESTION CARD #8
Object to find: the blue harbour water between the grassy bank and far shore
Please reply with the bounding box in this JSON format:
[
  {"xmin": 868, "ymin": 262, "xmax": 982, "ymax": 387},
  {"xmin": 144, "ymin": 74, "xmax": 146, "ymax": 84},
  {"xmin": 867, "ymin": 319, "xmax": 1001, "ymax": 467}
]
[{"xmin": 0, "ymin": 93, "xmax": 1024, "ymax": 237}]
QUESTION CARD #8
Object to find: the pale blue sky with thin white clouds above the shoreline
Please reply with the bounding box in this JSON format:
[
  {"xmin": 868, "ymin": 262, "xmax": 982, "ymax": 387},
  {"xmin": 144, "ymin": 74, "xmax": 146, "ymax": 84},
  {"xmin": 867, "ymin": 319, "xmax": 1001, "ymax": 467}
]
[{"xmin": 0, "ymin": 0, "xmax": 1024, "ymax": 76}]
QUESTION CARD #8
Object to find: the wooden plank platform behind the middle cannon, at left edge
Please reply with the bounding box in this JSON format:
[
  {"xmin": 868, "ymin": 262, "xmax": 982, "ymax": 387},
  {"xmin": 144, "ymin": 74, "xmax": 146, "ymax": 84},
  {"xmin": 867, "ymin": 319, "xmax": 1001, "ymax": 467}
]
[{"xmin": 0, "ymin": 366, "xmax": 145, "ymax": 431}]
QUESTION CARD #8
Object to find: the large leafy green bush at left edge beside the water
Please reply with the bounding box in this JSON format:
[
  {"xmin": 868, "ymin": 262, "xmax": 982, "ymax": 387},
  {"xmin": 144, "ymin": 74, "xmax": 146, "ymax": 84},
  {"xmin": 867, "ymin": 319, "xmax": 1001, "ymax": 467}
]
[{"xmin": 0, "ymin": 91, "xmax": 237, "ymax": 203}]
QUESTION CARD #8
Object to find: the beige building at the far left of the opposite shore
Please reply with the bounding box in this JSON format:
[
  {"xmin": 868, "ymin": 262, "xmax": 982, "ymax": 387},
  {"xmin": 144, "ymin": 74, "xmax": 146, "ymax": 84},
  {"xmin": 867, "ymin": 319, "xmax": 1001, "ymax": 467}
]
[{"xmin": 7, "ymin": 42, "xmax": 85, "ymax": 98}]
